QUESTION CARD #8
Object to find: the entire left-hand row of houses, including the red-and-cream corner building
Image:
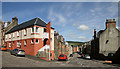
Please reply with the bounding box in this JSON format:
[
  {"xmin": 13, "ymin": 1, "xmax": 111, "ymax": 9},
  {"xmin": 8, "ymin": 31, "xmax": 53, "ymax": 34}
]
[{"xmin": 0, "ymin": 17, "xmax": 72, "ymax": 60}]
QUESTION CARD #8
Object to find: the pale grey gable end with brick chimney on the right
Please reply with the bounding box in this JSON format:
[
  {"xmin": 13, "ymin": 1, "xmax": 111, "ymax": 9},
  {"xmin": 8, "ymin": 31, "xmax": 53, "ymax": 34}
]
[{"xmin": 99, "ymin": 19, "xmax": 120, "ymax": 56}]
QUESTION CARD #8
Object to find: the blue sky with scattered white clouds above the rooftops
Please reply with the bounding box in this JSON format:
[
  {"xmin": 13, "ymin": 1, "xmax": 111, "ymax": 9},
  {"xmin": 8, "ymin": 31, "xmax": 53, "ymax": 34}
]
[{"xmin": 2, "ymin": 2, "xmax": 118, "ymax": 41}]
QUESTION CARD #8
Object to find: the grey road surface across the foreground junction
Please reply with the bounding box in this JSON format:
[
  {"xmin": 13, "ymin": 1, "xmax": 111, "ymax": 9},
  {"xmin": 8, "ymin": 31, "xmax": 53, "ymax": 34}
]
[{"xmin": 2, "ymin": 52, "xmax": 118, "ymax": 67}]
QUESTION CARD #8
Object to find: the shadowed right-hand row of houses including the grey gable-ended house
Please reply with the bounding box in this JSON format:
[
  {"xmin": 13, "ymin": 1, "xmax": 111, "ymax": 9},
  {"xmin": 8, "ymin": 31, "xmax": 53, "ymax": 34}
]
[{"xmin": 80, "ymin": 19, "xmax": 120, "ymax": 60}]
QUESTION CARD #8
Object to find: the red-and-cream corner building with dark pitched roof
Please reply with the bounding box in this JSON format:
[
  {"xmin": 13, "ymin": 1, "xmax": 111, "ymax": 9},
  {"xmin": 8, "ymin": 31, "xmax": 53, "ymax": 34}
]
[{"xmin": 5, "ymin": 17, "xmax": 54, "ymax": 60}]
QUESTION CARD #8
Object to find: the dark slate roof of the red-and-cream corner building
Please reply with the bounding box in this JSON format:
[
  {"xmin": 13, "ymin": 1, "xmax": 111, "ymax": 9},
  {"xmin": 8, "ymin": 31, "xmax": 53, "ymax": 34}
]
[{"xmin": 6, "ymin": 17, "xmax": 54, "ymax": 34}]
